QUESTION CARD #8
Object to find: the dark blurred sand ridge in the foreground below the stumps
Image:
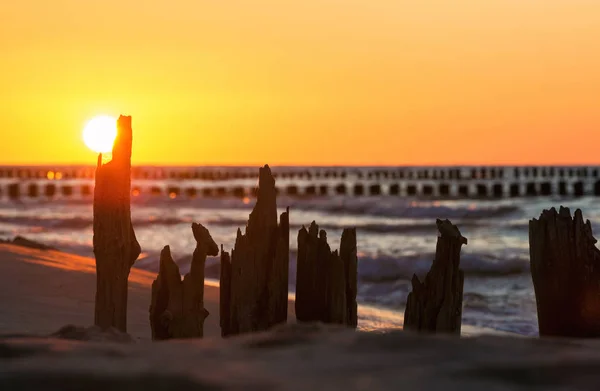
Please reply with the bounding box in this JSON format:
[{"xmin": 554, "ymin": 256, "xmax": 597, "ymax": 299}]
[{"xmin": 0, "ymin": 324, "xmax": 600, "ymax": 391}]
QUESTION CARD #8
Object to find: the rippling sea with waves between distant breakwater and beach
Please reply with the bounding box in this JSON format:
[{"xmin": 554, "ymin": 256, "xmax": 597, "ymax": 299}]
[{"xmin": 0, "ymin": 165, "xmax": 600, "ymax": 336}]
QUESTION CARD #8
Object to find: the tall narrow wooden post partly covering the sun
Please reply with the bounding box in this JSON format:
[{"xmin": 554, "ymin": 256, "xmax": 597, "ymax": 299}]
[{"xmin": 94, "ymin": 116, "xmax": 141, "ymax": 332}]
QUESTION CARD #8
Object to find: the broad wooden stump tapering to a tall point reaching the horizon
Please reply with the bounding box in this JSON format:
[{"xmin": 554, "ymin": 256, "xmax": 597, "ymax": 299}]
[{"xmin": 220, "ymin": 166, "xmax": 290, "ymax": 336}]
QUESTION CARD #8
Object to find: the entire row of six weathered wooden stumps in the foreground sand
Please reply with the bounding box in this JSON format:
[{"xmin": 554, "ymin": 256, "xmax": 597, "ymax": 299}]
[{"xmin": 93, "ymin": 116, "xmax": 600, "ymax": 340}]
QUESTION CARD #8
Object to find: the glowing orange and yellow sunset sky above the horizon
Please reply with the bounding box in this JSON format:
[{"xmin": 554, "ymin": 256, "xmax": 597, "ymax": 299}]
[{"xmin": 0, "ymin": 0, "xmax": 600, "ymax": 165}]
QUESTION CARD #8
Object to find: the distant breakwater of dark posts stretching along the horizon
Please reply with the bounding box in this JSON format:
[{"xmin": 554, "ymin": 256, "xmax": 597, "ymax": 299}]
[{"xmin": 0, "ymin": 166, "xmax": 600, "ymax": 200}]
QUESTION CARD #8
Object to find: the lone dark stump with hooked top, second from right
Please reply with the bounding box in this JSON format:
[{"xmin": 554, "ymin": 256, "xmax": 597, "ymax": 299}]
[{"xmin": 404, "ymin": 219, "xmax": 467, "ymax": 335}]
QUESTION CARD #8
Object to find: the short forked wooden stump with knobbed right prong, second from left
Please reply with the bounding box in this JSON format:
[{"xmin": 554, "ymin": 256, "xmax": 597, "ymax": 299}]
[{"xmin": 150, "ymin": 223, "xmax": 219, "ymax": 340}]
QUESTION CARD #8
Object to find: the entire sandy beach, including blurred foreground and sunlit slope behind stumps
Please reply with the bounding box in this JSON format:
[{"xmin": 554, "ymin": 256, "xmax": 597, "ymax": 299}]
[{"xmin": 8, "ymin": 240, "xmax": 600, "ymax": 391}]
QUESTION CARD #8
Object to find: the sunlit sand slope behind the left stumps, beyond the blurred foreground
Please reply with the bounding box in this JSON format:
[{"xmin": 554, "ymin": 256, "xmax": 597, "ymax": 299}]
[{"xmin": 0, "ymin": 244, "xmax": 294, "ymax": 341}]
